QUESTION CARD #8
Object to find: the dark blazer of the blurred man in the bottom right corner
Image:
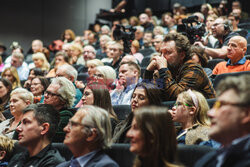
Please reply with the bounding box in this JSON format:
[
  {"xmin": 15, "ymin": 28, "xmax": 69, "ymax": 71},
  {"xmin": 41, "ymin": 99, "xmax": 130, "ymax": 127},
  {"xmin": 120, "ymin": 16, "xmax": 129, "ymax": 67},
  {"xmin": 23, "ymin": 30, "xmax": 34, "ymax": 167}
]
[{"xmin": 195, "ymin": 135, "xmax": 250, "ymax": 167}]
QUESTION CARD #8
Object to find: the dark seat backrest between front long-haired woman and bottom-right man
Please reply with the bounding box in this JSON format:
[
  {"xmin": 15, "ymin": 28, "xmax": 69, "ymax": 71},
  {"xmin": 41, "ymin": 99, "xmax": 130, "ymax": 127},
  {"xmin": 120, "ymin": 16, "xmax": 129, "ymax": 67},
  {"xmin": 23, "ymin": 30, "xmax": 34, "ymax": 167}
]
[{"xmin": 177, "ymin": 145, "xmax": 215, "ymax": 167}]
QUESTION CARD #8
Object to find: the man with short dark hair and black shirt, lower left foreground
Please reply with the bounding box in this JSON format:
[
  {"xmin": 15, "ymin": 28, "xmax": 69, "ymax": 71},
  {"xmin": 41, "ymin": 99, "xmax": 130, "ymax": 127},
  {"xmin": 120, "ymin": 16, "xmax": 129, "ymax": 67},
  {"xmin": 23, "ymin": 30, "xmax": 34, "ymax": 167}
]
[{"xmin": 8, "ymin": 104, "xmax": 65, "ymax": 167}]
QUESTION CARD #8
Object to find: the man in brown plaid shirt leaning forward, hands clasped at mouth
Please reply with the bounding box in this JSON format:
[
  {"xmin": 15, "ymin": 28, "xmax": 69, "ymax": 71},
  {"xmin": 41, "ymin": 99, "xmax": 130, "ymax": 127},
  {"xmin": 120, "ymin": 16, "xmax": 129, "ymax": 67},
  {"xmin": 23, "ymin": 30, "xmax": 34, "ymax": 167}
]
[{"xmin": 144, "ymin": 33, "xmax": 215, "ymax": 101}]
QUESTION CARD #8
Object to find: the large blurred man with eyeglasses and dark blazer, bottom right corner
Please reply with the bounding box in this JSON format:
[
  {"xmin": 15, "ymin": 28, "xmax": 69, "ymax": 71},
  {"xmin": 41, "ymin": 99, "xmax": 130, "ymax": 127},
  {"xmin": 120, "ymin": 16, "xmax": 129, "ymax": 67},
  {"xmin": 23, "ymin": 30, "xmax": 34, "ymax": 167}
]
[{"xmin": 196, "ymin": 75, "xmax": 250, "ymax": 167}]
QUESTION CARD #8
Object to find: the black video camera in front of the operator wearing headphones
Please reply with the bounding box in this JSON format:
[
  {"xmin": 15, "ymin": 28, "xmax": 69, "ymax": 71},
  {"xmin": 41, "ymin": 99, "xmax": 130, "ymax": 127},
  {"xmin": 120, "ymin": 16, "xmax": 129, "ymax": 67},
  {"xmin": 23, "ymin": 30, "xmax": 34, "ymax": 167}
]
[{"xmin": 177, "ymin": 16, "xmax": 206, "ymax": 44}]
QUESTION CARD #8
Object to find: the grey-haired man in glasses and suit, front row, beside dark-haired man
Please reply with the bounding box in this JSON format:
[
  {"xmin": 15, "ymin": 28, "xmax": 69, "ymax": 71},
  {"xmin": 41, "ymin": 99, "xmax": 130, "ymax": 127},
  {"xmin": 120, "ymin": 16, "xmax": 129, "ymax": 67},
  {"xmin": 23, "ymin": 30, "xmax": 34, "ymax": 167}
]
[{"xmin": 58, "ymin": 105, "xmax": 118, "ymax": 167}]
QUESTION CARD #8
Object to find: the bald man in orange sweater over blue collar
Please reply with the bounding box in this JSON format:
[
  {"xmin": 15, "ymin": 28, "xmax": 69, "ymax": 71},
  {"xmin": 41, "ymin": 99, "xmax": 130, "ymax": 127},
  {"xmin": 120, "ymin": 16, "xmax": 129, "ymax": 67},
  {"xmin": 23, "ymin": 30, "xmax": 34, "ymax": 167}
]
[{"xmin": 213, "ymin": 36, "xmax": 250, "ymax": 75}]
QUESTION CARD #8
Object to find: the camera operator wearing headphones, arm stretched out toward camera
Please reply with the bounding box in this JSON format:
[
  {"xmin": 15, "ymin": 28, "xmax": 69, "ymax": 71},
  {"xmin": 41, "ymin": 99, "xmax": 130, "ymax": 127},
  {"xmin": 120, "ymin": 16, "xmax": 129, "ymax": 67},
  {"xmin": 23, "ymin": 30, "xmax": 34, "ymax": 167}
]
[{"xmin": 194, "ymin": 17, "xmax": 239, "ymax": 59}]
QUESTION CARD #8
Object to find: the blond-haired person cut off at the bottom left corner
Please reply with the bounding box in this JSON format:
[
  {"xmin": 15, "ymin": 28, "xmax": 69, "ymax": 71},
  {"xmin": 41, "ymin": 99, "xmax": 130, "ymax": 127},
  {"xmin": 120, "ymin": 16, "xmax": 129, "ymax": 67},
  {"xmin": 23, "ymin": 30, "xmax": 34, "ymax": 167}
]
[{"xmin": 0, "ymin": 136, "xmax": 15, "ymax": 167}]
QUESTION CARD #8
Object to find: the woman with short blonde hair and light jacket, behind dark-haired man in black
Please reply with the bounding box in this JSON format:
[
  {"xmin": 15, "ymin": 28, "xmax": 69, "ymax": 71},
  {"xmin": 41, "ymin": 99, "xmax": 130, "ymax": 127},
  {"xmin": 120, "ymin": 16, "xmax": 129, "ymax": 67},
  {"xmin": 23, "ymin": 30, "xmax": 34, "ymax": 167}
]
[{"xmin": 0, "ymin": 88, "xmax": 34, "ymax": 138}]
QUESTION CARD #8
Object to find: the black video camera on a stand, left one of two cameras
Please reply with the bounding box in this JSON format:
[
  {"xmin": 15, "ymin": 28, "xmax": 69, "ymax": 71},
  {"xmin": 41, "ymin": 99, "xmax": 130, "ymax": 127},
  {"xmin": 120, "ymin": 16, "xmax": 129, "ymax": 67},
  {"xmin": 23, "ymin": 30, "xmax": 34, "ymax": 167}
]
[{"xmin": 113, "ymin": 24, "xmax": 136, "ymax": 53}]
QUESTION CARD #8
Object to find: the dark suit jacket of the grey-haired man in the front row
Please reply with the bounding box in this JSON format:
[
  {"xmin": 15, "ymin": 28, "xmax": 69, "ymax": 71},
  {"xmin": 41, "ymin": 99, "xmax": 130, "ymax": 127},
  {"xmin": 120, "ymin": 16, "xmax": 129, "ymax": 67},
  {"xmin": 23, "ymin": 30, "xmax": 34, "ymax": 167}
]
[{"xmin": 57, "ymin": 150, "xmax": 119, "ymax": 167}]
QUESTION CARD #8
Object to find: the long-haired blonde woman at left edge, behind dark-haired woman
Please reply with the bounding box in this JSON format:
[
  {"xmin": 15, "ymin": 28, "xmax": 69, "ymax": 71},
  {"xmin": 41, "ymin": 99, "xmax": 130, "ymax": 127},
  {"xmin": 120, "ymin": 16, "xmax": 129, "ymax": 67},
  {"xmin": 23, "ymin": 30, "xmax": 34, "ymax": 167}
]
[{"xmin": 1, "ymin": 67, "xmax": 21, "ymax": 89}]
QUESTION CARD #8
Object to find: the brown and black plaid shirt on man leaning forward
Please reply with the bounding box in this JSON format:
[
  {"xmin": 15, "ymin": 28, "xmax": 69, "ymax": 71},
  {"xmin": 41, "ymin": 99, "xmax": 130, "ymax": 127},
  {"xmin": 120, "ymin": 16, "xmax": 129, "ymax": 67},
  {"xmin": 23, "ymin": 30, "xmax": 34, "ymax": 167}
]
[{"xmin": 144, "ymin": 60, "xmax": 215, "ymax": 101}]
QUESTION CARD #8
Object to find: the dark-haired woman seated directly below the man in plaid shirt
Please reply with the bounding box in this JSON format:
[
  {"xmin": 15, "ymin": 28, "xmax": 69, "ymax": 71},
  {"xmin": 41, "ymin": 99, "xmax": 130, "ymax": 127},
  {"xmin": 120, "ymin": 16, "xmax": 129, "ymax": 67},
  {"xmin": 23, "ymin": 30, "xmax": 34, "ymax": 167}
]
[{"xmin": 112, "ymin": 82, "xmax": 162, "ymax": 143}]
